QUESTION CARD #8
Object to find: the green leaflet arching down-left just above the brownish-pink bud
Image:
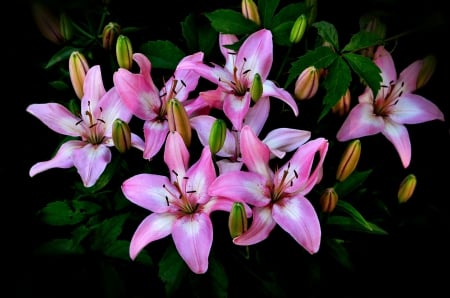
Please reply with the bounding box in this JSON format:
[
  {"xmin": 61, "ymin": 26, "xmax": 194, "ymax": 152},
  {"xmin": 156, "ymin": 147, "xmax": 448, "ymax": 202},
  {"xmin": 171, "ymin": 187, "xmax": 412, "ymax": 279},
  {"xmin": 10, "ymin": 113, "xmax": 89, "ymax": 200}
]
[{"xmin": 285, "ymin": 47, "xmax": 339, "ymax": 88}]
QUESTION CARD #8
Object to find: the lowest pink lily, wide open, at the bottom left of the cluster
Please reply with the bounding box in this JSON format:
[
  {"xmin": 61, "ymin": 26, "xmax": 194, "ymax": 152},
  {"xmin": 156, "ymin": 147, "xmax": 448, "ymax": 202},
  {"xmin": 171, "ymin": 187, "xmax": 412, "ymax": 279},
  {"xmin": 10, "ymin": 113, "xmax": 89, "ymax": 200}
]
[{"xmin": 122, "ymin": 132, "xmax": 246, "ymax": 274}]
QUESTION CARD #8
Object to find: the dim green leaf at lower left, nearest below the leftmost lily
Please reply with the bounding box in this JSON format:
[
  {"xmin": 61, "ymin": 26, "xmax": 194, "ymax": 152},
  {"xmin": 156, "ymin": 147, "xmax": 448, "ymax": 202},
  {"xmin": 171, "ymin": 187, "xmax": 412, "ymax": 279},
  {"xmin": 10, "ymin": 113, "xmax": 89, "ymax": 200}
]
[{"xmin": 38, "ymin": 201, "xmax": 101, "ymax": 226}]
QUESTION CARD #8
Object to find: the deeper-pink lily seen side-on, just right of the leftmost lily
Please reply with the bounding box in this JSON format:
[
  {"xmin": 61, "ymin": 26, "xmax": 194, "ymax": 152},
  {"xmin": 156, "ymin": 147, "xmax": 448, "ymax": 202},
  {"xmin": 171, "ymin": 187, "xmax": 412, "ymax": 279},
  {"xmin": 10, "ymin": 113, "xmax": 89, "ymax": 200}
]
[{"xmin": 113, "ymin": 53, "xmax": 208, "ymax": 159}]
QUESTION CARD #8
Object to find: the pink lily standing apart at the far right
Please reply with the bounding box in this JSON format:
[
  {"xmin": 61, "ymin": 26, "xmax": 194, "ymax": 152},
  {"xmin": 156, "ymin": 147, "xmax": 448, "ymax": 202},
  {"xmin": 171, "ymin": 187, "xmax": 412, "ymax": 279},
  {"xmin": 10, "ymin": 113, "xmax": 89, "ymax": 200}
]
[{"xmin": 336, "ymin": 46, "xmax": 444, "ymax": 168}]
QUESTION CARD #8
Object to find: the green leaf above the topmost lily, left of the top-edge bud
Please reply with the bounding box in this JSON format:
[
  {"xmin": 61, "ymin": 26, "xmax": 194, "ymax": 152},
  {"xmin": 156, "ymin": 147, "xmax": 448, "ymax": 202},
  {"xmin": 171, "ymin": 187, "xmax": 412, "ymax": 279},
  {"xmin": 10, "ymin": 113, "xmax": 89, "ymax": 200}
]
[{"xmin": 205, "ymin": 9, "xmax": 259, "ymax": 35}]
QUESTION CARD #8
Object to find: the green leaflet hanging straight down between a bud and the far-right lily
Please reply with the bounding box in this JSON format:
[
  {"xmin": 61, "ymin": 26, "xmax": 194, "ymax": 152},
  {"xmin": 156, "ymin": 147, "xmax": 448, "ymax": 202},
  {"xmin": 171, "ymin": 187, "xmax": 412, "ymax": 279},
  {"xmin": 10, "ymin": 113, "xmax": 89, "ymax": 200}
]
[{"xmin": 319, "ymin": 58, "xmax": 352, "ymax": 121}]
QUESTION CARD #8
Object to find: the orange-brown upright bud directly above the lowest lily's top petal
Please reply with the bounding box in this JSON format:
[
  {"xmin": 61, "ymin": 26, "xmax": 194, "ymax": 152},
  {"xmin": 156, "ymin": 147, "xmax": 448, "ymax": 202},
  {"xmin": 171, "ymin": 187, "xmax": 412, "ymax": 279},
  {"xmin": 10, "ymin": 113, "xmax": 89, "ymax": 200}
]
[{"xmin": 167, "ymin": 98, "xmax": 192, "ymax": 147}]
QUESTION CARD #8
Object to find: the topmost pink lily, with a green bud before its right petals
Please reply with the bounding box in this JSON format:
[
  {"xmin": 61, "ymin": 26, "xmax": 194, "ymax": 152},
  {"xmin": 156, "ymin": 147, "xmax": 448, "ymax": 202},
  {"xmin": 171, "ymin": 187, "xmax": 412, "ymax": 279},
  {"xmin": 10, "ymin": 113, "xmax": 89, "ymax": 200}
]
[{"xmin": 179, "ymin": 29, "xmax": 298, "ymax": 130}]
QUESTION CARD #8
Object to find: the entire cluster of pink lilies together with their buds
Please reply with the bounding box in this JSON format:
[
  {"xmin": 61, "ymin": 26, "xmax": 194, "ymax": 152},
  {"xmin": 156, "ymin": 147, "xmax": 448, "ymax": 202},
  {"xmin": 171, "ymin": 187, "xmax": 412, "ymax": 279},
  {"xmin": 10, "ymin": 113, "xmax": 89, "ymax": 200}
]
[{"xmin": 27, "ymin": 0, "xmax": 444, "ymax": 274}]
